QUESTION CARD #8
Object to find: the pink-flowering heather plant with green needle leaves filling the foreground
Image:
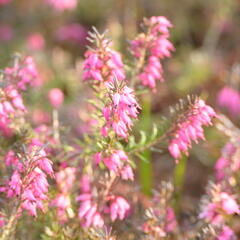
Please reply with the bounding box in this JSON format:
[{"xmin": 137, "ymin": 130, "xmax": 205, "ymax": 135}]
[{"xmin": 0, "ymin": 12, "xmax": 240, "ymax": 240}]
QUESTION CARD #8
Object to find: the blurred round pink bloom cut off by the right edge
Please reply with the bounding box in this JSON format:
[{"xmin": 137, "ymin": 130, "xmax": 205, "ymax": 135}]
[{"xmin": 217, "ymin": 86, "xmax": 240, "ymax": 116}]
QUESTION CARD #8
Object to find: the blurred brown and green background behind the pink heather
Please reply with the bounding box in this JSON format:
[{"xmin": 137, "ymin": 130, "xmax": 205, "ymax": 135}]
[{"xmin": 0, "ymin": 0, "xmax": 240, "ymax": 231}]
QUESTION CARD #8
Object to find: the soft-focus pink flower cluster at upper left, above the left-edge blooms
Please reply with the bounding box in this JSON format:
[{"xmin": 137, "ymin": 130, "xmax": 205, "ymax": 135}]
[{"xmin": 4, "ymin": 57, "xmax": 42, "ymax": 90}]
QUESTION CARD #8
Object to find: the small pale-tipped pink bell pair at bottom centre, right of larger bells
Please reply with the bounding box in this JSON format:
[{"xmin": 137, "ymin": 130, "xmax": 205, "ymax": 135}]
[{"xmin": 110, "ymin": 196, "xmax": 130, "ymax": 222}]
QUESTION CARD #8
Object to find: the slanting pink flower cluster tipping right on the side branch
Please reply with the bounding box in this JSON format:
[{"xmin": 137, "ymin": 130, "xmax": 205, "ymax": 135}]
[{"xmin": 168, "ymin": 99, "xmax": 216, "ymax": 161}]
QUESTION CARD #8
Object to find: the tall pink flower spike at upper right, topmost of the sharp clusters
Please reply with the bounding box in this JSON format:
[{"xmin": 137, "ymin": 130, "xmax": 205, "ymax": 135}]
[{"xmin": 131, "ymin": 16, "xmax": 174, "ymax": 91}]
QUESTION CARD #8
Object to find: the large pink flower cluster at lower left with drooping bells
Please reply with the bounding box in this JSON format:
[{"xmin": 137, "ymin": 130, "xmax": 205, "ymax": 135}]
[{"xmin": 0, "ymin": 139, "xmax": 54, "ymax": 216}]
